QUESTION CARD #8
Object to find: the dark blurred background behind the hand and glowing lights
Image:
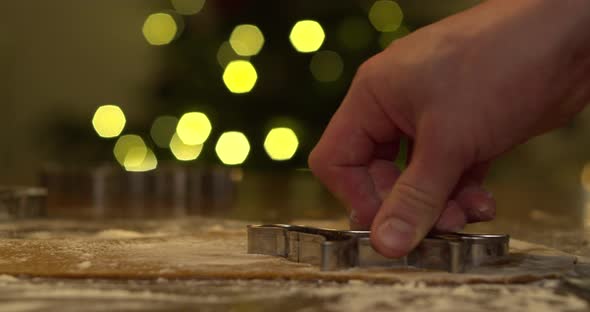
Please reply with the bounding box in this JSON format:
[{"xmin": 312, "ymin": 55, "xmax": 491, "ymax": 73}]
[{"xmin": 0, "ymin": 0, "xmax": 590, "ymax": 227}]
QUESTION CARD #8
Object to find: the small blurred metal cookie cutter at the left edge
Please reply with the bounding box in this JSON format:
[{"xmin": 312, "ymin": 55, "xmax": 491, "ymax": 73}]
[{"xmin": 0, "ymin": 186, "xmax": 47, "ymax": 221}]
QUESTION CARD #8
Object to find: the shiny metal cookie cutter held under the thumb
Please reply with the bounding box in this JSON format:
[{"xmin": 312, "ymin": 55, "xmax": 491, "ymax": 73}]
[{"xmin": 248, "ymin": 224, "xmax": 510, "ymax": 273}]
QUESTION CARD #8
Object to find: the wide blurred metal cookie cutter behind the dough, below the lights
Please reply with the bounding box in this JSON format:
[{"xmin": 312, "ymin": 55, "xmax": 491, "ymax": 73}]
[{"xmin": 41, "ymin": 164, "xmax": 242, "ymax": 218}]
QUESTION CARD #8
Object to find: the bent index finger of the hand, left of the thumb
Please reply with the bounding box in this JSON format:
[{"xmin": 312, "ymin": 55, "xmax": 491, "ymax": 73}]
[{"xmin": 309, "ymin": 61, "xmax": 400, "ymax": 228}]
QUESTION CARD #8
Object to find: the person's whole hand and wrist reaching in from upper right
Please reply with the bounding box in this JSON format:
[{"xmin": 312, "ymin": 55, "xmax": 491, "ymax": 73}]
[{"xmin": 309, "ymin": 0, "xmax": 590, "ymax": 257}]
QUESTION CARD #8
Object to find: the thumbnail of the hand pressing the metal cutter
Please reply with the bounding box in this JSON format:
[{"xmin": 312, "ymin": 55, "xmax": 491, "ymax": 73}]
[{"xmin": 377, "ymin": 218, "xmax": 415, "ymax": 254}]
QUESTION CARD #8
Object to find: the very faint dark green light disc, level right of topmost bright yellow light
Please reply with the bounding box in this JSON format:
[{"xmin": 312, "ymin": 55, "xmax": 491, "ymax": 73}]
[{"xmin": 338, "ymin": 17, "xmax": 375, "ymax": 51}]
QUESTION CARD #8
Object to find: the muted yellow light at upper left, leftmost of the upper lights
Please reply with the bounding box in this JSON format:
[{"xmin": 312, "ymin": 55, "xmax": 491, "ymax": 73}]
[{"xmin": 142, "ymin": 13, "xmax": 178, "ymax": 45}]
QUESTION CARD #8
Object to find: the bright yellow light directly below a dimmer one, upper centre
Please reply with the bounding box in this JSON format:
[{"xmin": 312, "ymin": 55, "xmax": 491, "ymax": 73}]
[{"xmin": 223, "ymin": 60, "xmax": 258, "ymax": 93}]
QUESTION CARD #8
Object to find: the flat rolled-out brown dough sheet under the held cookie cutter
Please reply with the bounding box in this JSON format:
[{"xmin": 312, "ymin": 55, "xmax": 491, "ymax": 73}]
[{"xmin": 0, "ymin": 218, "xmax": 577, "ymax": 284}]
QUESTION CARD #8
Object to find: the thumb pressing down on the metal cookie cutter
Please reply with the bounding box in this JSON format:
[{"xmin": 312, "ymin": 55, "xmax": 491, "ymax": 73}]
[{"xmin": 371, "ymin": 127, "xmax": 468, "ymax": 258}]
